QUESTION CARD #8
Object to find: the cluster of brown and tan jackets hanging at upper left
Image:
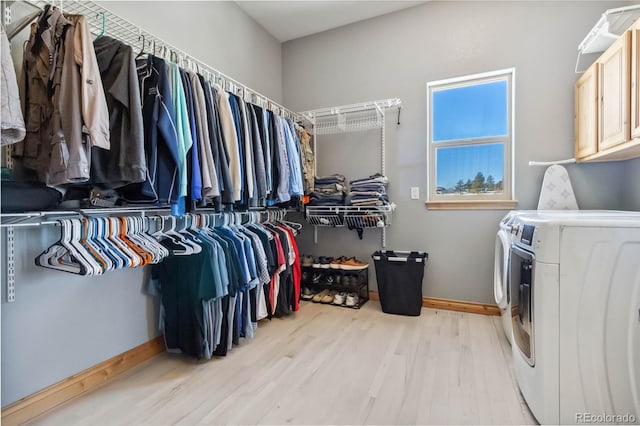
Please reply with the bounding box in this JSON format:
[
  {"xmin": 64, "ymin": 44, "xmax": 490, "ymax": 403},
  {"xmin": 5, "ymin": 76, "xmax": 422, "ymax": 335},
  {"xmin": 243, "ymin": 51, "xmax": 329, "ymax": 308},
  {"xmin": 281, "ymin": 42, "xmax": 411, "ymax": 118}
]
[{"xmin": 14, "ymin": 5, "xmax": 110, "ymax": 186}]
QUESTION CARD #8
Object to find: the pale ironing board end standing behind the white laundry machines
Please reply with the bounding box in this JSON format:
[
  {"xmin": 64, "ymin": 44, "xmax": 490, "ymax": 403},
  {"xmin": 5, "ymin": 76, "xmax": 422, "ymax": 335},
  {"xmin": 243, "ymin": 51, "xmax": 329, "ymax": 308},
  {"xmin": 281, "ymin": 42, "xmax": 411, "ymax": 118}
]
[{"xmin": 538, "ymin": 164, "xmax": 578, "ymax": 210}]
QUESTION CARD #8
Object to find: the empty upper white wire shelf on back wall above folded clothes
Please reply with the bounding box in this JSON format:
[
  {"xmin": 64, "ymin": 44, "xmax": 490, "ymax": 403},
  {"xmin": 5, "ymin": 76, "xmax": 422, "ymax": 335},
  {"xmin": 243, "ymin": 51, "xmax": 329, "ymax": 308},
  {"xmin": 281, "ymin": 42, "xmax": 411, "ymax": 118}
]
[{"xmin": 298, "ymin": 98, "xmax": 401, "ymax": 135}]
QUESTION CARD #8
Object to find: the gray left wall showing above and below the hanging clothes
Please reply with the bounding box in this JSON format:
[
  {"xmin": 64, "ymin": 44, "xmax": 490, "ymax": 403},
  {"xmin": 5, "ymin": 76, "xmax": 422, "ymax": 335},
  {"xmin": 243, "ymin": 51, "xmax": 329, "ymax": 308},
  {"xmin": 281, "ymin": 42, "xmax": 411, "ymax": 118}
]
[{"xmin": 1, "ymin": 2, "xmax": 282, "ymax": 406}]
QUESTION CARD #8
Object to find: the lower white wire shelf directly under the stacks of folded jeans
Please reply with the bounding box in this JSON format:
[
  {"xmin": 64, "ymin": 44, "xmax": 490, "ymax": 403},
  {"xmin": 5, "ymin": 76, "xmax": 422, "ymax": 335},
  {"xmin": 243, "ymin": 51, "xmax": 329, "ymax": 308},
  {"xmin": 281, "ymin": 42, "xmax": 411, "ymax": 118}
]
[{"xmin": 305, "ymin": 204, "xmax": 395, "ymax": 228}]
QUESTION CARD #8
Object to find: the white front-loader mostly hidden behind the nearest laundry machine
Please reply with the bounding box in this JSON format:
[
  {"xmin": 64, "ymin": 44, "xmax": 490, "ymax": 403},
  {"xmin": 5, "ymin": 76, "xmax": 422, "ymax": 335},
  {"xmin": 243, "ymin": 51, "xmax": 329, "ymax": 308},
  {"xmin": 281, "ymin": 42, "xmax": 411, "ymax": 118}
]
[{"xmin": 493, "ymin": 211, "xmax": 521, "ymax": 345}]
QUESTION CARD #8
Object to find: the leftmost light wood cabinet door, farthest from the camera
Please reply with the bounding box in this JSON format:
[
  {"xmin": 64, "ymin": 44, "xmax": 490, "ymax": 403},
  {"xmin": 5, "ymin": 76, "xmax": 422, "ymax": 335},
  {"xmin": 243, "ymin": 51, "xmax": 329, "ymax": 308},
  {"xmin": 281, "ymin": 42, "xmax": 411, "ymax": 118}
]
[{"xmin": 575, "ymin": 64, "xmax": 598, "ymax": 159}]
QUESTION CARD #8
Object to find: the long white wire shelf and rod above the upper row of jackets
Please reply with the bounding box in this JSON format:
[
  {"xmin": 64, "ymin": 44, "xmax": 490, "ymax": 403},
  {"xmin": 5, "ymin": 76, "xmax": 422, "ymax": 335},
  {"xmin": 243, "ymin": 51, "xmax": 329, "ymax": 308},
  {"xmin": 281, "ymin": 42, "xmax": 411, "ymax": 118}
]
[{"xmin": 25, "ymin": 0, "xmax": 301, "ymax": 121}]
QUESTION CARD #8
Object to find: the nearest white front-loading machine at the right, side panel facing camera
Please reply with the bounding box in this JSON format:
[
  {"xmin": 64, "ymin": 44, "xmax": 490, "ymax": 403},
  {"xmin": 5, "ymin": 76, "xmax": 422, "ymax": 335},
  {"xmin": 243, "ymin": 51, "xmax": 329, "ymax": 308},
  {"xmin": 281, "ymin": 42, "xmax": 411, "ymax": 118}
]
[{"xmin": 508, "ymin": 211, "xmax": 640, "ymax": 424}]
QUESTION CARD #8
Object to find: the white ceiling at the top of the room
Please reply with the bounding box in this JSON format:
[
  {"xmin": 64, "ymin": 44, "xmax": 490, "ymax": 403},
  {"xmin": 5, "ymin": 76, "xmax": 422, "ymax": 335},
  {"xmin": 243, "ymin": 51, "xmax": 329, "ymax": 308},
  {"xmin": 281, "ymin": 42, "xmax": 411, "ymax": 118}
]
[{"xmin": 236, "ymin": 0, "xmax": 425, "ymax": 43}]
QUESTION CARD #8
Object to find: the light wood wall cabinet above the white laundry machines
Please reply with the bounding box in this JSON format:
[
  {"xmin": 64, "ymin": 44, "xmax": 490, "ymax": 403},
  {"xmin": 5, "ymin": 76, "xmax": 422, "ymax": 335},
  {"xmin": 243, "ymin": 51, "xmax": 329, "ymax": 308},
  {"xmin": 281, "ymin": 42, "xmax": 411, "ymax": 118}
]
[{"xmin": 575, "ymin": 20, "xmax": 640, "ymax": 162}]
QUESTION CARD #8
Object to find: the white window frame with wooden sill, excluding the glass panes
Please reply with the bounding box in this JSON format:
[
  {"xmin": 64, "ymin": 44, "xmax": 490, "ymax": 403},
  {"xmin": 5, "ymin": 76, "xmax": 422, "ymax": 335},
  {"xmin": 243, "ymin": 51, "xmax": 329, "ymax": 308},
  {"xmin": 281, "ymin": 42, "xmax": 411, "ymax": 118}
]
[{"xmin": 426, "ymin": 68, "xmax": 516, "ymax": 209}]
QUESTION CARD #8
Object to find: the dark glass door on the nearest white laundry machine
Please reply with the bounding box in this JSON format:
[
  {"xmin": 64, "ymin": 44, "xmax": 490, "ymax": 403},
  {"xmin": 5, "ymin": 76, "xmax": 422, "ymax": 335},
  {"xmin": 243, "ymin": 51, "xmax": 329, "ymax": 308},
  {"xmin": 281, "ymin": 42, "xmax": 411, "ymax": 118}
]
[{"xmin": 509, "ymin": 244, "xmax": 535, "ymax": 366}]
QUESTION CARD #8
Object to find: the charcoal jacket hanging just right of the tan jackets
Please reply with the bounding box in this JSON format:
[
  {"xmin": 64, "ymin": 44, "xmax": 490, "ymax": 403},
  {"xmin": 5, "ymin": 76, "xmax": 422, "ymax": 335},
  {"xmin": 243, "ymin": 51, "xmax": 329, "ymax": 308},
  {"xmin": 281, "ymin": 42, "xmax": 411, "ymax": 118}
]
[{"xmin": 91, "ymin": 36, "xmax": 147, "ymax": 188}]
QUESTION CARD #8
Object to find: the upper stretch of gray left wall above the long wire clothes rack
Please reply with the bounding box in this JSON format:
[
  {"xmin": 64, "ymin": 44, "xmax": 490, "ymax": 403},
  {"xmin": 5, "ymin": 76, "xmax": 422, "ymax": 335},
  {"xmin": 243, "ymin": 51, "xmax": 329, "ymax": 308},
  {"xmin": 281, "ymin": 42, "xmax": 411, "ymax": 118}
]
[{"xmin": 98, "ymin": 1, "xmax": 282, "ymax": 102}]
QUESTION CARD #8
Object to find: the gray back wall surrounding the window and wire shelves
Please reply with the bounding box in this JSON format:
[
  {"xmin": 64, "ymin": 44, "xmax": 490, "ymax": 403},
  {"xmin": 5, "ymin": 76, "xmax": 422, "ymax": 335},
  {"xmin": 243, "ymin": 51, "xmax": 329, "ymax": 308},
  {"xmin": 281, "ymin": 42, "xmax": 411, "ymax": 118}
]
[{"xmin": 282, "ymin": 1, "xmax": 638, "ymax": 303}]
